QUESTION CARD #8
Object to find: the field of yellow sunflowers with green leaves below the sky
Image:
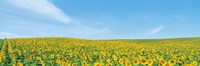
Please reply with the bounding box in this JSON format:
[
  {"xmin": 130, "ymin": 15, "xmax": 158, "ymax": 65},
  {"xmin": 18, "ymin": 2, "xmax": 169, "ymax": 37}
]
[{"xmin": 0, "ymin": 38, "xmax": 200, "ymax": 66}]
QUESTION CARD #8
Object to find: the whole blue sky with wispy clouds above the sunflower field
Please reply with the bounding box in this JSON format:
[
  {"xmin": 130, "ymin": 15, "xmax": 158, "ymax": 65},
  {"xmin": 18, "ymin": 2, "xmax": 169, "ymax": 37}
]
[{"xmin": 0, "ymin": 0, "xmax": 200, "ymax": 39}]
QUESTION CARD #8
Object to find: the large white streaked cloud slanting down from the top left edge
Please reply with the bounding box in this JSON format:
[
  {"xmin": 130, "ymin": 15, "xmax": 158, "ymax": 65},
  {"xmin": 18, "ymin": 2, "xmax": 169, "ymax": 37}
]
[{"xmin": 6, "ymin": 0, "xmax": 72, "ymax": 23}]
